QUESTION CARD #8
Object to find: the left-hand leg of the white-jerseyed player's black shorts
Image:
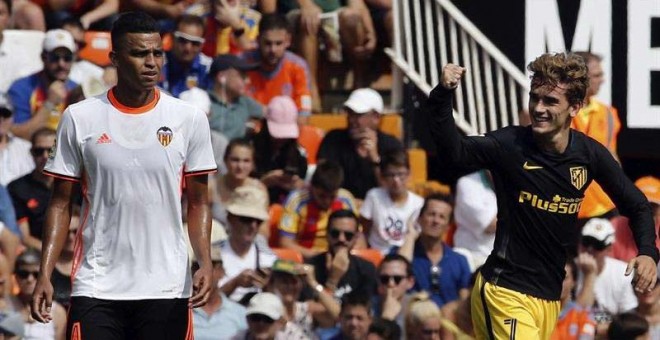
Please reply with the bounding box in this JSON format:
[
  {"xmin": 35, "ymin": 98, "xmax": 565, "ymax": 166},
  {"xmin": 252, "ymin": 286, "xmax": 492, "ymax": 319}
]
[{"xmin": 66, "ymin": 296, "xmax": 127, "ymax": 340}]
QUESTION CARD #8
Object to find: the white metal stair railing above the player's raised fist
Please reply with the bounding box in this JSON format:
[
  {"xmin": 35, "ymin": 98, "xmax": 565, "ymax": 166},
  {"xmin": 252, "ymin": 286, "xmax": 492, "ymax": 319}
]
[{"xmin": 386, "ymin": 0, "xmax": 529, "ymax": 135}]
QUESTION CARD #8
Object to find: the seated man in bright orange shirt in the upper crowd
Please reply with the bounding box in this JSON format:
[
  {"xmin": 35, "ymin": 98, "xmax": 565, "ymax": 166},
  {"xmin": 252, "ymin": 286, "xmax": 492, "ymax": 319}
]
[{"xmin": 246, "ymin": 14, "xmax": 312, "ymax": 123}]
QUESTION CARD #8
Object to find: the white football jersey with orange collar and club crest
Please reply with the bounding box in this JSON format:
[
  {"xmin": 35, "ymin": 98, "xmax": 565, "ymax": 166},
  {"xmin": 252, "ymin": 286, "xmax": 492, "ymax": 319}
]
[{"xmin": 44, "ymin": 90, "xmax": 216, "ymax": 300}]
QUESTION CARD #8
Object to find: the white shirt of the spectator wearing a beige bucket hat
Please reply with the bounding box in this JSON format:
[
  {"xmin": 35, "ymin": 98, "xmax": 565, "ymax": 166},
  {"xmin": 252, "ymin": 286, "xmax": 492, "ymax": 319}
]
[{"xmin": 218, "ymin": 241, "xmax": 277, "ymax": 301}]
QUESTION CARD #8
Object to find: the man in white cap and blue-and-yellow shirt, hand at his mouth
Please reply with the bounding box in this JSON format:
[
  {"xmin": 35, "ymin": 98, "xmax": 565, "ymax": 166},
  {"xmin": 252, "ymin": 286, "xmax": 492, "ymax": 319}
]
[{"xmin": 7, "ymin": 29, "xmax": 78, "ymax": 139}]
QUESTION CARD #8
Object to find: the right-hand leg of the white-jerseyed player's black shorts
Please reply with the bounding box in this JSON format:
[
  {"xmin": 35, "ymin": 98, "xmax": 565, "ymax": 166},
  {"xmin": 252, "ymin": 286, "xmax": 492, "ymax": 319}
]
[{"xmin": 128, "ymin": 299, "xmax": 192, "ymax": 340}]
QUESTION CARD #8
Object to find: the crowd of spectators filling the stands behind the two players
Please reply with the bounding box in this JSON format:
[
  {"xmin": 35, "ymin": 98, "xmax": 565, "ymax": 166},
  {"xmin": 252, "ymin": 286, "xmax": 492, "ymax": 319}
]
[{"xmin": 0, "ymin": 0, "xmax": 660, "ymax": 339}]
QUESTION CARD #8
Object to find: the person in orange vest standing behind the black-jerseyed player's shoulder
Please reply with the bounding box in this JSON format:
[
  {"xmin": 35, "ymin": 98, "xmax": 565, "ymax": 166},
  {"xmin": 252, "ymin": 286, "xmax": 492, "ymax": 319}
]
[{"xmin": 571, "ymin": 52, "xmax": 621, "ymax": 219}]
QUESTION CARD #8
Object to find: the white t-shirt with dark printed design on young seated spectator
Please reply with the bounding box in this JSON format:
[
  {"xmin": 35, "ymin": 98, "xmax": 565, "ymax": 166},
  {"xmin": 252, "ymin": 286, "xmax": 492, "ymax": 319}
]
[{"xmin": 360, "ymin": 187, "xmax": 424, "ymax": 254}]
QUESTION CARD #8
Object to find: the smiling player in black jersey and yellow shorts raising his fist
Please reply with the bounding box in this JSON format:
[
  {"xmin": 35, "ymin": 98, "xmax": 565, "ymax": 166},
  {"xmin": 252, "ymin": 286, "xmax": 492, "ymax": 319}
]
[{"xmin": 426, "ymin": 53, "xmax": 658, "ymax": 339}]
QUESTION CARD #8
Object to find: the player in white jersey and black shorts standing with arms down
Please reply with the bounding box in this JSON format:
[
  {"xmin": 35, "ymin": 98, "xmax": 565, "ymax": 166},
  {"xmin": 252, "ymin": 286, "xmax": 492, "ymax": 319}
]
[{"xmin": 32, "ymin": 12, "xmax": 216, "ymax": 340}]
